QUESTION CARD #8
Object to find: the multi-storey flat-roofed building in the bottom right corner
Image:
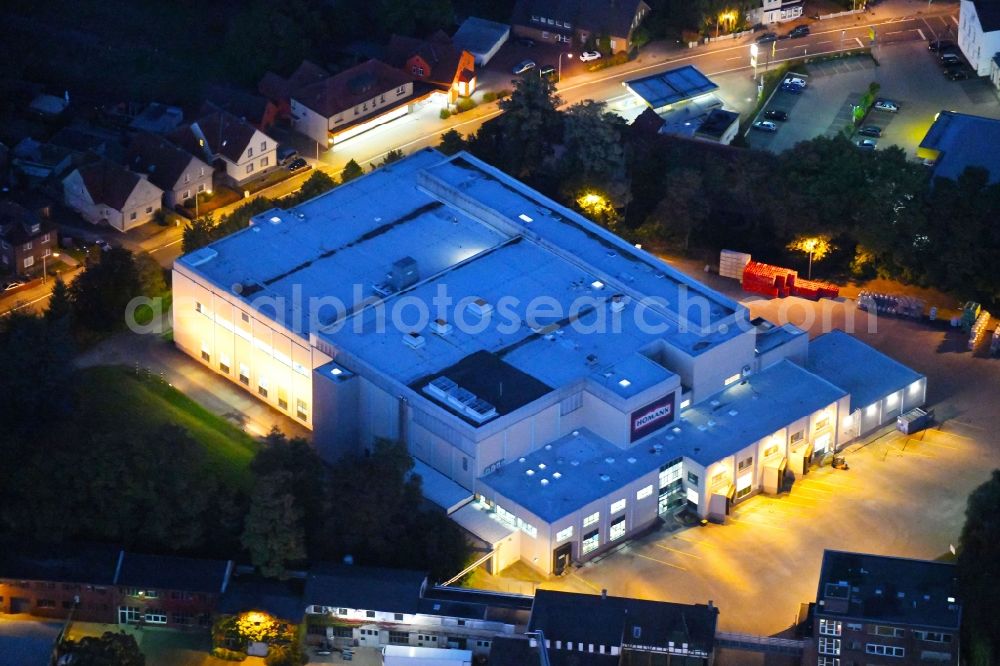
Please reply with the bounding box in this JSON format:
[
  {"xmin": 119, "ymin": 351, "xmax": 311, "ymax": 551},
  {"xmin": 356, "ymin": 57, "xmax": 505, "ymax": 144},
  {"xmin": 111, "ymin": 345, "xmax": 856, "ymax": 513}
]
[{"xmin": 802, "ymin": 550, "xmax": 962, "ymax": 666}]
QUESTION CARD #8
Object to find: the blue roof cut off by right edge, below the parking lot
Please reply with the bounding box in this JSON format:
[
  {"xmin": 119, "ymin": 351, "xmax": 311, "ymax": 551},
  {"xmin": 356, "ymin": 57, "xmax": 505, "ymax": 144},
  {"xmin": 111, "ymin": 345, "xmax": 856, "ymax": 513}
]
[{"xmin": 920, "ymin": 111, "xmax": 1000, "ymax": 182}]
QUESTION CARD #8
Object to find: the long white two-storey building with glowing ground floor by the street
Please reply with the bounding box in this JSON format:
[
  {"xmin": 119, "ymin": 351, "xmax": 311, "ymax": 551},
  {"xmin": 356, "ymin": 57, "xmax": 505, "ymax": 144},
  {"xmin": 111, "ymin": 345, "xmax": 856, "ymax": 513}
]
[{"xmin": 291, "ymin": 59, "xmax": 433, "ymax": 146}]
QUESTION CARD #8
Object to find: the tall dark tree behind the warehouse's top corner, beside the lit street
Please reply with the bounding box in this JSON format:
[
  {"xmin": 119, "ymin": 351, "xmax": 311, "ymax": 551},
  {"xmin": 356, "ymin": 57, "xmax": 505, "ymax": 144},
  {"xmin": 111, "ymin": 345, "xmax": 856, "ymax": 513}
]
[{"xmin": 491, "ymin": 76, "xmax": 561, "ymax": 179}]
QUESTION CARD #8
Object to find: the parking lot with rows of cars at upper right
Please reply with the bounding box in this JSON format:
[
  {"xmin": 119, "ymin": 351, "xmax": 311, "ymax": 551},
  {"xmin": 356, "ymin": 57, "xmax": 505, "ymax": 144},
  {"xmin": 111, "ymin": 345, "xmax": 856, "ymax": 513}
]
[{"xmin": 747, "ymin": 25, "xmax": 1000, "ymax": 157}]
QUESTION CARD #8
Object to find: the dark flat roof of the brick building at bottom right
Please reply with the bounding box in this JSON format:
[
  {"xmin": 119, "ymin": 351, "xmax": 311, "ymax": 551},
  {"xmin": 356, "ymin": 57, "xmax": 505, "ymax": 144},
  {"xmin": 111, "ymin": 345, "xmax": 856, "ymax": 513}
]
[{"xmin": 817, "ymin": 550, "xmax": 962, "ymax": 629}]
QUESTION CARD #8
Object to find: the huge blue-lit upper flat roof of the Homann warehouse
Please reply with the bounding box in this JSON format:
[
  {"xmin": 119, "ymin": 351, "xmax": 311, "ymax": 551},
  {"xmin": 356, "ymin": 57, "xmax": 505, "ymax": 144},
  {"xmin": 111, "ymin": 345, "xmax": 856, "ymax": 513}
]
[{"xmin": 177, "ymin": 149, "xmax": 746, "ymax": 388}]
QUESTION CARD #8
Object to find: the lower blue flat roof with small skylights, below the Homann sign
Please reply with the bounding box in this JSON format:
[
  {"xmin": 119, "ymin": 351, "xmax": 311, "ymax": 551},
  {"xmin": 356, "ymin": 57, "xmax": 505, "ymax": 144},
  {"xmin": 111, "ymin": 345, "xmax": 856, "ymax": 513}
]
[{"xmin": 480, "ymin": 360, "xmax": 844, "ymax": 522}]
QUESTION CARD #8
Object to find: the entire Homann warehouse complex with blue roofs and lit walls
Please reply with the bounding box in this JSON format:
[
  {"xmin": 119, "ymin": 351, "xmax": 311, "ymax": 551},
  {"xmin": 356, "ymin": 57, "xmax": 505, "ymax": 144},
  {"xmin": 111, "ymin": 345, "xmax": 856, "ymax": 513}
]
[{"xmin": 173, "ymin": 149, "xmax": 926, "ymax": 573}]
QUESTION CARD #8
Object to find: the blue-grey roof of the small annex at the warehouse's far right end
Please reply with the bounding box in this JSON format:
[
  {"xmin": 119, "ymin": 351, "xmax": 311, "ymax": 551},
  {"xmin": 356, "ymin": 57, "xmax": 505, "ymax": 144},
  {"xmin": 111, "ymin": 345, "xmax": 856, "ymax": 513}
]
[{"xmin": 806, "ymin": 330, "xmax": 923, "ymax": 411}]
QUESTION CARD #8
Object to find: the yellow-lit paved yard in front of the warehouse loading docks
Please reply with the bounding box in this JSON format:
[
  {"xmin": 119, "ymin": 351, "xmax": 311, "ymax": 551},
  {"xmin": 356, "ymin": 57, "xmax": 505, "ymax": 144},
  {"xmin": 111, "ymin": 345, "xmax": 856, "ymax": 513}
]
[{"xmin": 541, "ymin": 299, "xmax": 1000, "ymax": 635}]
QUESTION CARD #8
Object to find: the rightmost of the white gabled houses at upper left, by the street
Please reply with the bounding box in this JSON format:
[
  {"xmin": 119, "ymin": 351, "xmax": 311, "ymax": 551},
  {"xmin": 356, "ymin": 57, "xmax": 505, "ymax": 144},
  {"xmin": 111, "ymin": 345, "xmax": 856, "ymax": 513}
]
[{"xmin": 171, "ymin": 111, "xmax": 278, "ymax": 187}]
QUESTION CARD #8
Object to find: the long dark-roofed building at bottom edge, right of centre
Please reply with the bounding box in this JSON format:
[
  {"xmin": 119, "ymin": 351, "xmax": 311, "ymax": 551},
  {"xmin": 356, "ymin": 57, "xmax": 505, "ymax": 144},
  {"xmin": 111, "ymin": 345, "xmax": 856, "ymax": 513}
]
[{"xmin": 490, "ymin": 590, "xmax": 719, "ymax": 666}]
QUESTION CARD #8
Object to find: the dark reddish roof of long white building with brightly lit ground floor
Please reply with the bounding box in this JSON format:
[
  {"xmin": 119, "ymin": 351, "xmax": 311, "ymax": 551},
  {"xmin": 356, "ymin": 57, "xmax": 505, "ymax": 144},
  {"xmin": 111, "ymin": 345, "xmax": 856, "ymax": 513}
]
[{"xmin": 292, "ymin": 60, "xmax": 412, "ymax": 118}]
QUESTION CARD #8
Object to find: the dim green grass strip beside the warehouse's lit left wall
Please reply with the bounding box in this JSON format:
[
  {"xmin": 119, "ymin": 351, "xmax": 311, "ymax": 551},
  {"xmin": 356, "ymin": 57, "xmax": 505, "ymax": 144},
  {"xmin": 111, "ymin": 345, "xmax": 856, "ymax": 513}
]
[{"xmin": 77, "ymin": 366, "xmax": 257, "ymax": 488}]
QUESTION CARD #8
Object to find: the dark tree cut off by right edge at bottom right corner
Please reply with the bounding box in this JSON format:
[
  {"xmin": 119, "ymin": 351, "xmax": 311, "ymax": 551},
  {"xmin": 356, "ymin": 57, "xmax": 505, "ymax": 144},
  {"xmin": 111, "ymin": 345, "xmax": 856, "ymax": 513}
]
[{"xmin": 957, "ymin": 469, "xmax": 1000, "ymax": 666}]
